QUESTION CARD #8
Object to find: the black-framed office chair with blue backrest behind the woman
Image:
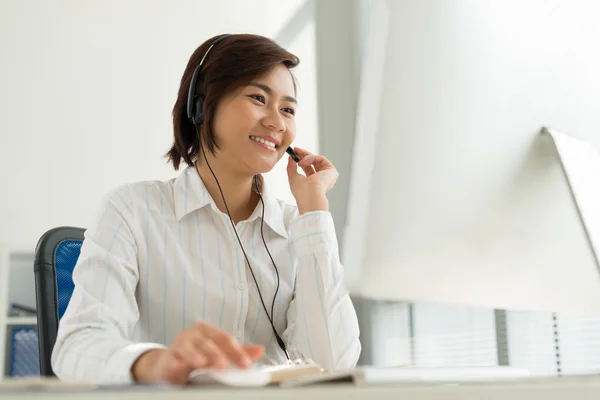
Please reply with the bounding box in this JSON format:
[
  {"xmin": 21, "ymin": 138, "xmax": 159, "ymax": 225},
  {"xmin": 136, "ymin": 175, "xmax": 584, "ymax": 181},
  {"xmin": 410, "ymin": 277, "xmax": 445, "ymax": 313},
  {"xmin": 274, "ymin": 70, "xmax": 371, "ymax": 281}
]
[{"xmin": 33, "ymin": 226, "xmax": 85, "ymax": 376}]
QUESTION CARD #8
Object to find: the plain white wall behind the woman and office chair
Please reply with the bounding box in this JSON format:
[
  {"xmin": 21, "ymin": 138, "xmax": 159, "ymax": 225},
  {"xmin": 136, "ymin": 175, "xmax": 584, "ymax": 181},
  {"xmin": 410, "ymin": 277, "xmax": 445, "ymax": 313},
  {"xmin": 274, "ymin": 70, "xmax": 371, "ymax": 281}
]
[{"xmin": 0, "ymin": 0, "xmax": 317, "ymax": 250}]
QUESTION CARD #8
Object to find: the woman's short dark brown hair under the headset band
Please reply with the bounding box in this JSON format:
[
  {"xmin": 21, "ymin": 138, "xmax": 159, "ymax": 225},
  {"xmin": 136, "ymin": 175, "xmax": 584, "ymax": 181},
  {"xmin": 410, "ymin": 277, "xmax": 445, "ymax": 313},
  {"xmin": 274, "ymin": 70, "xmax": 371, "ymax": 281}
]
[{"xmin": 165, "ymin": 34, "xmax": 300, "ymax": 170}]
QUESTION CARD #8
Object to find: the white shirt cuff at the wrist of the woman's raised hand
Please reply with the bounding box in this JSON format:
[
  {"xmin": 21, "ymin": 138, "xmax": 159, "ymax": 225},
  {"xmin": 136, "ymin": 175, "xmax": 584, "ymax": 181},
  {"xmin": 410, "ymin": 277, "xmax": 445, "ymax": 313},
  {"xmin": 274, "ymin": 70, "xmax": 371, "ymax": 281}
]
[{"xmin": 290, "ymin": 211, "xmax": 338, "ymax": 257}]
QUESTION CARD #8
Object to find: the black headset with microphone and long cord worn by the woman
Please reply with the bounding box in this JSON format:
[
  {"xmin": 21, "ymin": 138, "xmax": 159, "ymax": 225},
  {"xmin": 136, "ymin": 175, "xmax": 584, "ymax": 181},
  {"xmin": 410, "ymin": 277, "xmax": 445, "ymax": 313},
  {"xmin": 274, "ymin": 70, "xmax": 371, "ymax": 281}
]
[{"xmin": 187, "ymin": 34, "xmax": 300, "ymax": 361}]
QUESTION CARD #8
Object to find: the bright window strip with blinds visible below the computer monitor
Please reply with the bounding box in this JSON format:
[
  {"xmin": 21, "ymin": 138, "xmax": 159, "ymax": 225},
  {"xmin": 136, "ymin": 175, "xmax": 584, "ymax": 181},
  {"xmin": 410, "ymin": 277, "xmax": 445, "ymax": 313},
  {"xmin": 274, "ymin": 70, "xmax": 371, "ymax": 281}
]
[{"xmin": 364, "ymin": 301, "xmax": 600, "ymax": 376}]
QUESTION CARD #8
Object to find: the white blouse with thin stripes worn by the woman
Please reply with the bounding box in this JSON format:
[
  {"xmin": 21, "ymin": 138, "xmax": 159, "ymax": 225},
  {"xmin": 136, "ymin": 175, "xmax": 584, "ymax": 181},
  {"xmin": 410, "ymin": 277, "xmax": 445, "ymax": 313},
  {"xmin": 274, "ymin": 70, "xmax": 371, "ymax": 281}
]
[{"xmin": 52, "ymin": 167, "xmax": 361, "ymax": 383}]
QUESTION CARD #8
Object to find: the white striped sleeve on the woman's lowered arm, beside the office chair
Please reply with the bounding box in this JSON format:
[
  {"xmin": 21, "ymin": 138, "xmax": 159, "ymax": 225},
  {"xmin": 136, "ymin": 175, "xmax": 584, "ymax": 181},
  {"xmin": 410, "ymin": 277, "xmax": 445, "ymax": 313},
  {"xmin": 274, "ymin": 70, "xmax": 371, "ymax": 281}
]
[{"xmin": 52, "ymin": 191, "xmax": 164, "ymax": 383}]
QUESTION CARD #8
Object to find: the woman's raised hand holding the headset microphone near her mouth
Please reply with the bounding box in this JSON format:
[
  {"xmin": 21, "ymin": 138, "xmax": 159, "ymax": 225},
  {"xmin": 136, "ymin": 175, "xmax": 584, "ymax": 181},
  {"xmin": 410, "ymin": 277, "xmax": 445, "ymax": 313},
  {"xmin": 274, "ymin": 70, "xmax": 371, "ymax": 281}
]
[{"xmin": 287, "ymin": 147, "xmax": 339, "ymax": 214}]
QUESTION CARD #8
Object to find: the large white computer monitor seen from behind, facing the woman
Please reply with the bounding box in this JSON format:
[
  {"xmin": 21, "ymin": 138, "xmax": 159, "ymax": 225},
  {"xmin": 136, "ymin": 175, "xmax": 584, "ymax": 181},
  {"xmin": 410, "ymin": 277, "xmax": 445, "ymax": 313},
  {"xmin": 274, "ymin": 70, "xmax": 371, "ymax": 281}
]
[{"xmin": 342, "ymin": 1, "xmax": 600, "ymax": 314}]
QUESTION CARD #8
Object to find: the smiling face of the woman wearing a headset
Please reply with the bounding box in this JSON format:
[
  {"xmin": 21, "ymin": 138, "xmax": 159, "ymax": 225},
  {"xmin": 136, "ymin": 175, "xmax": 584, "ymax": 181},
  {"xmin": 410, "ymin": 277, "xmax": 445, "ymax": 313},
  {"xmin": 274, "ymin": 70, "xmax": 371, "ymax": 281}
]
[{"xmin": 213, "ymin": 64, "xmax": 296, "ymax": 175}]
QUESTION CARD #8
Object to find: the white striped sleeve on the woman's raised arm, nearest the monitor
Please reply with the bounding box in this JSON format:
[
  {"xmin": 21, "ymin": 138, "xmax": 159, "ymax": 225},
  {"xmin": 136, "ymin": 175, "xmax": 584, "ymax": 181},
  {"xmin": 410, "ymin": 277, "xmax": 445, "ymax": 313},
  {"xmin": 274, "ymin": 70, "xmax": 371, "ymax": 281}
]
[{"xmin": 283, "ymin": 211, "xmax": 361, "ymax": 370}]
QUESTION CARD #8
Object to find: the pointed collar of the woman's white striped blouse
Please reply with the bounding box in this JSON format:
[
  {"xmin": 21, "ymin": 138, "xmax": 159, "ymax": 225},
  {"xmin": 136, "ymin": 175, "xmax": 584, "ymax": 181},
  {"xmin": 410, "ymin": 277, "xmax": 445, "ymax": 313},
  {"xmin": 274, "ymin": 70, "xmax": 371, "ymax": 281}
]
[{"xmin": 173, "ymin": 166, "xmax": 288, "ymax": 238}]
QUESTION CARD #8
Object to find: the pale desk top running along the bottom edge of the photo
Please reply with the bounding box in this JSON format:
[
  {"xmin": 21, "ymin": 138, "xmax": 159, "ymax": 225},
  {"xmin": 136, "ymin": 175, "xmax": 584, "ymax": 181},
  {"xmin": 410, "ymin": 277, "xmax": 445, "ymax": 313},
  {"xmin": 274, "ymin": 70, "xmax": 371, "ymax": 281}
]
[{"xmin": 0, "ymin": 376, "xmax": 600, "ymax": 400}]
